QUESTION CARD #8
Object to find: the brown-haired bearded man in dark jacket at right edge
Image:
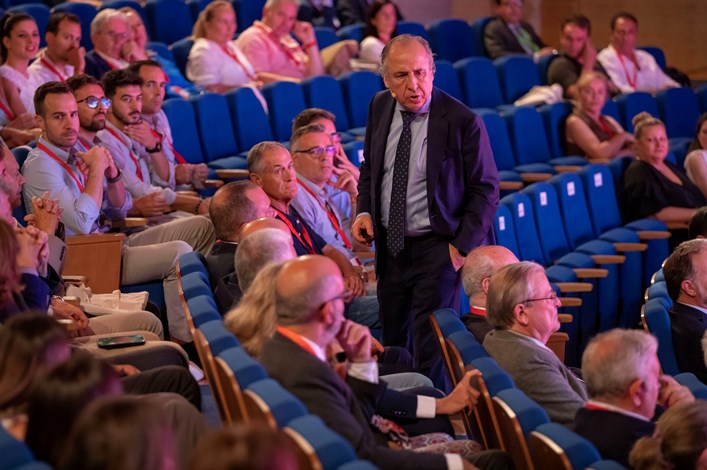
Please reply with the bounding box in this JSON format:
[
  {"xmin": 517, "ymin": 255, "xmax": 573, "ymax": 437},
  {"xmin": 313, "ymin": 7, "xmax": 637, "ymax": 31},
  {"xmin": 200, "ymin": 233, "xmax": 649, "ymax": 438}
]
[{"xmin": 663, "ymin": 239, "xmax": 707, "ymax": 383}]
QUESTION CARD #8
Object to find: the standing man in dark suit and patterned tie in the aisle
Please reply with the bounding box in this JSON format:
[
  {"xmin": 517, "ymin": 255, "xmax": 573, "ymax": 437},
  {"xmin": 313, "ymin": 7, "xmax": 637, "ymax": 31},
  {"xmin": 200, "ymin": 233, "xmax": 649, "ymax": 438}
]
[{"xmin": 351, "ymin": 34, "xmax": 498, "ymax": 385}]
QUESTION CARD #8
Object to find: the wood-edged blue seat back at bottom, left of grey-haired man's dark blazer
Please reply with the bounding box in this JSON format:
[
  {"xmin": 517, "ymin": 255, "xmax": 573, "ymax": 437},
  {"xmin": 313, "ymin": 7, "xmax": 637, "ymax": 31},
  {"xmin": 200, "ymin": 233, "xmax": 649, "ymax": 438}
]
[{"xmin": 528, "ymin": 423, "xmax": 601, "ymax": 470}]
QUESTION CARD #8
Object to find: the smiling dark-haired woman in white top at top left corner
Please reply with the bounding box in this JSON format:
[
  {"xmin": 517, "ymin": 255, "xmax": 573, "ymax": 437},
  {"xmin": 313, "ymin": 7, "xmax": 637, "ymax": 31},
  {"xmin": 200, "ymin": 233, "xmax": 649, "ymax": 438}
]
[{"xmin": 0, "ymin": 12, "xmax": 39, "ymax": 114}]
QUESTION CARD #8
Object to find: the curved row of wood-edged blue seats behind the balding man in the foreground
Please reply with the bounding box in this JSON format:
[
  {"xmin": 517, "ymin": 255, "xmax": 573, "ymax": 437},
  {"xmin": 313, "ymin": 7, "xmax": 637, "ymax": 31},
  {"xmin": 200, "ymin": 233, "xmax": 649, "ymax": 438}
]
[{"xmin": 177, "ymin": 253, "xmax": 376, "ymax": 470}]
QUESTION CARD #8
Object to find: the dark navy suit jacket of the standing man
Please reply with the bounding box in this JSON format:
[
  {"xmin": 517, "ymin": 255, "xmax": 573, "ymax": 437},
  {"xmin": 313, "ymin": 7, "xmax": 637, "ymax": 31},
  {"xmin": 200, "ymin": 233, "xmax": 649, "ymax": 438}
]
[{"xmin": 357, "ymin": 88, "xmax": 499, "ymax": 260}]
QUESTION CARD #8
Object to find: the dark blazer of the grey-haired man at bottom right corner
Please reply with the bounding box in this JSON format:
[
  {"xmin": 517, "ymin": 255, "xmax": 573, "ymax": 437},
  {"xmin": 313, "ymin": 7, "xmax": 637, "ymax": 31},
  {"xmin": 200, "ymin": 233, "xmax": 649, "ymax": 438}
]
[{"xmin": 573, "ymin": 408, "xmax": 655, "ymax": 466}]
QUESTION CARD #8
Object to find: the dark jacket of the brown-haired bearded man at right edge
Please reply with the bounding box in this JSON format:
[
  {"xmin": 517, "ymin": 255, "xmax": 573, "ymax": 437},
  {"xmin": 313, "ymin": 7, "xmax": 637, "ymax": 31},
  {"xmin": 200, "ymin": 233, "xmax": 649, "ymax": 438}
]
[{"xmin": 670, "ymin": 302, "xmax": 707, "ymax": 383}]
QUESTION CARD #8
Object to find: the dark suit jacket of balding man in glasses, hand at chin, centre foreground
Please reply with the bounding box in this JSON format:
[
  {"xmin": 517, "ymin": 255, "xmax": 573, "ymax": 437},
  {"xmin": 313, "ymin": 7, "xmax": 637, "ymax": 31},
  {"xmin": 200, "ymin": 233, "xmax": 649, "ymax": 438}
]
[{"xmin": 260, "ymin": 333, "xmax": 447, "ymax": 469}]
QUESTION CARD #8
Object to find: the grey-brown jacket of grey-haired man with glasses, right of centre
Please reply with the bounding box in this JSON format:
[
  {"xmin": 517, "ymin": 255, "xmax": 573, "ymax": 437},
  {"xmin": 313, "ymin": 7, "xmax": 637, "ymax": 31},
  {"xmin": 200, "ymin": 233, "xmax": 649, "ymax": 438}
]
[{"xmin": 484, "ymin": 330, "xmax": 588, "ymax": 424}]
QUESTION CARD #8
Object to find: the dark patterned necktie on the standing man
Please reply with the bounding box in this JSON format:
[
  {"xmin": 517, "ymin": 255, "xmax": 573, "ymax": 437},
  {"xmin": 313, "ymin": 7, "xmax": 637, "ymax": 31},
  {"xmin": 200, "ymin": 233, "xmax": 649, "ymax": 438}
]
[{"xmin": 388, "ymin": 111, "xmax": 415, "ymax": 256}]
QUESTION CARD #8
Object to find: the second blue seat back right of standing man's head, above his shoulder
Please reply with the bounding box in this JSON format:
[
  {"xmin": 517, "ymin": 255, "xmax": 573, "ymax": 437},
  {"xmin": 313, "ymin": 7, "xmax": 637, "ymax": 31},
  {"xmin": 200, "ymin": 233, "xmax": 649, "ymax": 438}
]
[{"xmin": 454, "ymin": 57, "xmax": 504, "ymax": 108}]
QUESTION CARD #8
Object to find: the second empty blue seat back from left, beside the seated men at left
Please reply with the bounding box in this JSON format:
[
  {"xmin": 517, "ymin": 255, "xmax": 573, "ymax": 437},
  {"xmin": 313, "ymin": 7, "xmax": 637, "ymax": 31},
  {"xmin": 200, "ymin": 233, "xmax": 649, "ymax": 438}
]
[{"xmin": 191, "ymin": 93, "xmax": 238, "ymax": 162}]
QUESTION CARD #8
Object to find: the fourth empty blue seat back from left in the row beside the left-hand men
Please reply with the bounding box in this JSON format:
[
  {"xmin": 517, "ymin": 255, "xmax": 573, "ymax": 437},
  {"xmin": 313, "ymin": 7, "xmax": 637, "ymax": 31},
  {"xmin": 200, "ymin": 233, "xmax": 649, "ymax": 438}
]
[{"xmin": 263, "ymin": 82, "xmax": 307, "ymax": 141}]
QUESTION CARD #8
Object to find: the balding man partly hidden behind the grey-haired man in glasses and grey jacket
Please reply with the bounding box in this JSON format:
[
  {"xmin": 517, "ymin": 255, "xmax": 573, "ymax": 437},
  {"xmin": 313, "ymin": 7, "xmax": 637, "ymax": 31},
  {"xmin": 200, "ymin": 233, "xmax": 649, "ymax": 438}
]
[{"xmin": 461, "ymin": 245, "xmax": 518, "ymax": 343}]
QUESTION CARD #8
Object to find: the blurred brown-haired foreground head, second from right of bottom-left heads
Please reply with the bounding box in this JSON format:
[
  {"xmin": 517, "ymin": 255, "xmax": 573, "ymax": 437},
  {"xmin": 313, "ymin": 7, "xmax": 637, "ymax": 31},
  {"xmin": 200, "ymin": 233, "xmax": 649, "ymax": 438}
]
[{"xmin": 57, "ymin": 397, "xmax": 180, "ymax": 470}]
